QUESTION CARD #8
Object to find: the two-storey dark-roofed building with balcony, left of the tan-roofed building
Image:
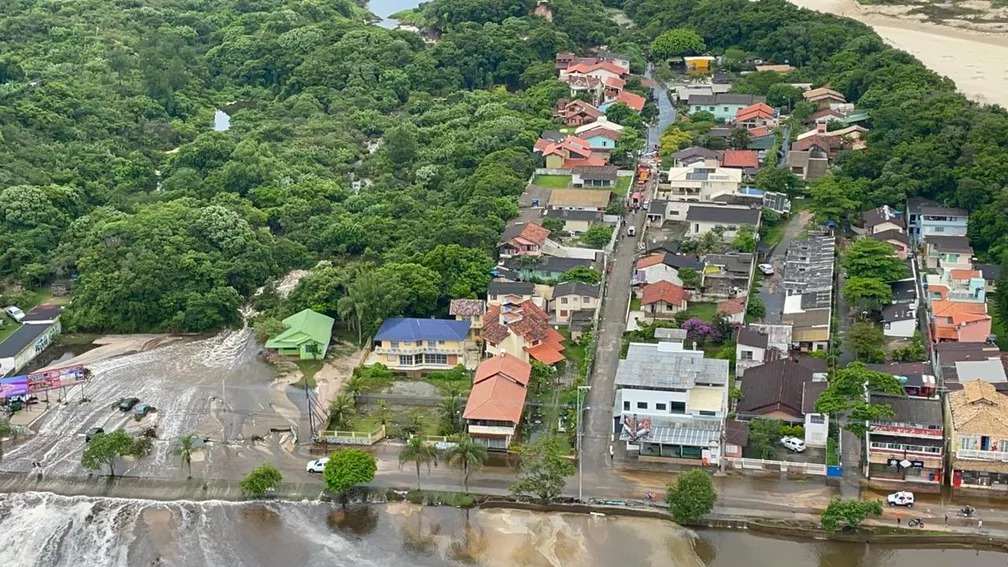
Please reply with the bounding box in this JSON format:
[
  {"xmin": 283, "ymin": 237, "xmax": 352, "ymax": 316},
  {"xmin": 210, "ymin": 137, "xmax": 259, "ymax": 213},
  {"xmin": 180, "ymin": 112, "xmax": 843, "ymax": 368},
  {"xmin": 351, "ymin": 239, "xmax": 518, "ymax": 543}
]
[{"xmin": 865, "ymin": 391, "xmax": 944, "ymax": 485}]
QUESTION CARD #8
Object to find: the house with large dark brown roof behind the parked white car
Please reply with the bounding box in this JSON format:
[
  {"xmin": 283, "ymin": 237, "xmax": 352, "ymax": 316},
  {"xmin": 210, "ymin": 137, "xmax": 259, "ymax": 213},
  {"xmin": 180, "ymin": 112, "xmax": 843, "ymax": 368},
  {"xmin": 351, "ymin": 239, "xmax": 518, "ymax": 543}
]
[{"xmin": 735, "ymin": 356, "xmax": 830, "ymax": 447}]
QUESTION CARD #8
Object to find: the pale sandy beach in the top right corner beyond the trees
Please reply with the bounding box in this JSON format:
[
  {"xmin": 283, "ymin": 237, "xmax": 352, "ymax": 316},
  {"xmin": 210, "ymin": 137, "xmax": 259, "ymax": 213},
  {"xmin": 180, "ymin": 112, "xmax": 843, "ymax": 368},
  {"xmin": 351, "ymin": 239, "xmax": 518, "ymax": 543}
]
[{"xmin": 790, "ymin": 0, "xmax": 1008, "ymax": 107}]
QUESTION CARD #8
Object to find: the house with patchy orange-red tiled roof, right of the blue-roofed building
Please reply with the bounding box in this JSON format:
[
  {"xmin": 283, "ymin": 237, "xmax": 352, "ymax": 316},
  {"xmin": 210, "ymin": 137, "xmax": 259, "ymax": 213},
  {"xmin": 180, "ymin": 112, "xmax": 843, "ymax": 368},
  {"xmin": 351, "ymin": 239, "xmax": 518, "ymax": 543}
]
[{"xmin": 483, "ymin": 301, "xmax": 565, "ymax": 364}]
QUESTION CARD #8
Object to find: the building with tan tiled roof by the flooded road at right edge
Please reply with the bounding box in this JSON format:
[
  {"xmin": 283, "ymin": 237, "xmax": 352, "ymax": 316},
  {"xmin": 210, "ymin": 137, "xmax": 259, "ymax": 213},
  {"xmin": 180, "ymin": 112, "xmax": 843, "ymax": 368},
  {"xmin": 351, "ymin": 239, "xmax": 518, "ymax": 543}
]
[{"xmin": 949, "ymin": 380, "xmax": 1008, "ymax": 490}]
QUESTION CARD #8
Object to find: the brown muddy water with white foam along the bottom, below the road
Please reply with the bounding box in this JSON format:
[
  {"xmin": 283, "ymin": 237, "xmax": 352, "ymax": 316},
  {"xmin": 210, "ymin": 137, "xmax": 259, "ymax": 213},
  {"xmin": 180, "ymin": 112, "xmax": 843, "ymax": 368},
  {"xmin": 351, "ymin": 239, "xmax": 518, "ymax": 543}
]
[{"xmin": 0, "ymin": 492, "xmax": 1008, "ymax": 567}]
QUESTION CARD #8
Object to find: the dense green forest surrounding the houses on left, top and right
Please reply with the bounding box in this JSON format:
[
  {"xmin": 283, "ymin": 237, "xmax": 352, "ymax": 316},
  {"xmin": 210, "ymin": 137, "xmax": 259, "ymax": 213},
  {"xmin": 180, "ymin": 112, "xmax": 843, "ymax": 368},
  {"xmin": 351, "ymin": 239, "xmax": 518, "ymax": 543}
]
[{"xmin": 0, "ymin": 0, "xmax": 1008, "ymax": 332}]
